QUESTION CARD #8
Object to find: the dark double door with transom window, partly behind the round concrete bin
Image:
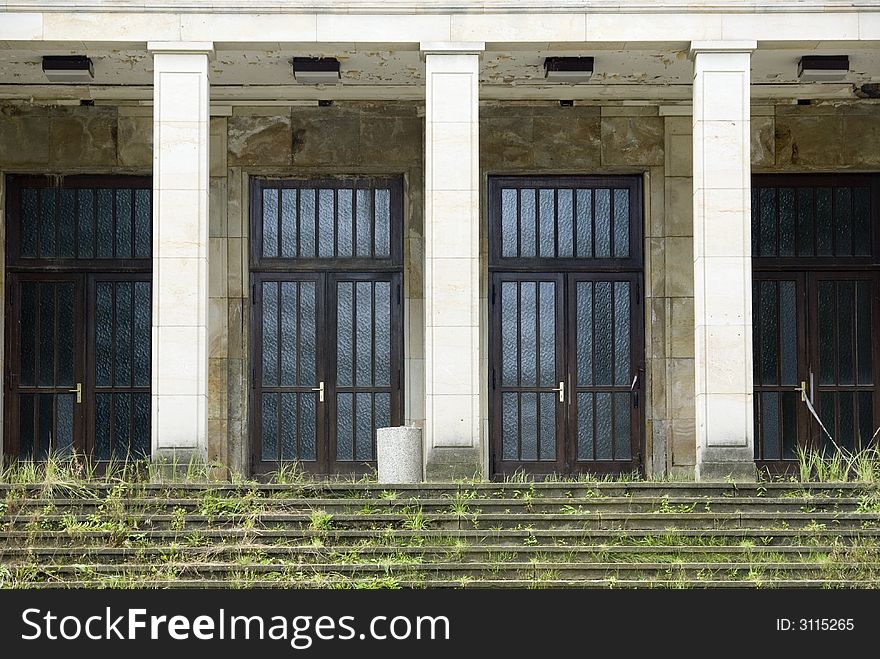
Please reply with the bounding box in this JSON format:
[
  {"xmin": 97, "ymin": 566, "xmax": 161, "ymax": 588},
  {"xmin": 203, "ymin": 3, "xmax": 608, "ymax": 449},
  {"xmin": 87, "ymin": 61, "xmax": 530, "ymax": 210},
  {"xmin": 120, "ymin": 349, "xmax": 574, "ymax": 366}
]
[{"xmin": 250, "ymin": 177, "xmax": 403, "ymax": 474}]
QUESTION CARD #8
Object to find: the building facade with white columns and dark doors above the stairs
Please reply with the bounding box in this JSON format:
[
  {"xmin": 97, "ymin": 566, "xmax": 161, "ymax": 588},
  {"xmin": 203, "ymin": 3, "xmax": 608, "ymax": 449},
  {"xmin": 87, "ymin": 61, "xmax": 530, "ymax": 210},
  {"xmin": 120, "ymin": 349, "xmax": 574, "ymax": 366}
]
[{"xmin": 0, "ymin": 0, "xmax": 880, "ymax": 479}]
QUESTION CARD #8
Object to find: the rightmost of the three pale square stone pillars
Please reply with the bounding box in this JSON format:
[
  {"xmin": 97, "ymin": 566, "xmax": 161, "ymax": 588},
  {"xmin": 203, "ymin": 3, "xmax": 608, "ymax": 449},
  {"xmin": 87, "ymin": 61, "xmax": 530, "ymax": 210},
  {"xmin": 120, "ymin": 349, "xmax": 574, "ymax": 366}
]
[{"xmin": 691, "ymin": 41, "xmax": 757, "ymax": 480}]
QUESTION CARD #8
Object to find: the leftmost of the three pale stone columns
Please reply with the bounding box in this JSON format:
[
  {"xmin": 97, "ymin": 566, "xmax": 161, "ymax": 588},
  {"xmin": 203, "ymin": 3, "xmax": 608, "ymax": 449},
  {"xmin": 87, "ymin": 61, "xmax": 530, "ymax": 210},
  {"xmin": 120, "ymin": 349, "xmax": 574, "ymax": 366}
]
[{"xmin": 148, "ymin": 42, "xmax": 213, "ymax": 462}]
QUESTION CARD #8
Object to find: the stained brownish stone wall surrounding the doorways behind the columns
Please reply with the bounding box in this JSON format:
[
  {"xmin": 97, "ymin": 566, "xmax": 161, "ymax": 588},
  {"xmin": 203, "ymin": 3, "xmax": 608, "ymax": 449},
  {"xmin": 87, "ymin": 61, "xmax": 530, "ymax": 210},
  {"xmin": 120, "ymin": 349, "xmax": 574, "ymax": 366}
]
[{"xmin": 0, "ymin": 102, "xmax": 880, "ymax": 475}]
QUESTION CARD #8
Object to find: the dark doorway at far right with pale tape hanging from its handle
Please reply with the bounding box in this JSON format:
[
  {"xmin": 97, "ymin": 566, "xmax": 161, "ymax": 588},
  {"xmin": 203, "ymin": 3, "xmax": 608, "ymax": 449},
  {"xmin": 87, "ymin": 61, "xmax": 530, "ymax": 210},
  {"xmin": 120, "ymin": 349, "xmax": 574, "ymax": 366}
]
[{"xmin": 752, "ymin": 175, "xmax": 880, "ymax": 471}]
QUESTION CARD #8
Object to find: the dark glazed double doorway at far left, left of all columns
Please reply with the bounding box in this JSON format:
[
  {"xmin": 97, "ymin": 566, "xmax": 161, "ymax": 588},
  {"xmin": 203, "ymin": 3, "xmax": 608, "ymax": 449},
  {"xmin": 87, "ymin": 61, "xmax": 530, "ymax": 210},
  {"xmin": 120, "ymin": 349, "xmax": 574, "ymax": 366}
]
[{"xmin": 4, "ymin": 176, "xmax": 152, "ymax": 462}]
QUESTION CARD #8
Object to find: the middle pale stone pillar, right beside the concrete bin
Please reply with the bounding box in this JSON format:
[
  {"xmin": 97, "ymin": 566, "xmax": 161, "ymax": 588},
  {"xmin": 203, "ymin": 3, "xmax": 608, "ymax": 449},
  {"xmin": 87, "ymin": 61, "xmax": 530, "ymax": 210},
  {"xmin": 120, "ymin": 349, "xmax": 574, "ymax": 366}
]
[{"xmin": 421, "ymin": 43, "xmax": 484, "ymax": 480}]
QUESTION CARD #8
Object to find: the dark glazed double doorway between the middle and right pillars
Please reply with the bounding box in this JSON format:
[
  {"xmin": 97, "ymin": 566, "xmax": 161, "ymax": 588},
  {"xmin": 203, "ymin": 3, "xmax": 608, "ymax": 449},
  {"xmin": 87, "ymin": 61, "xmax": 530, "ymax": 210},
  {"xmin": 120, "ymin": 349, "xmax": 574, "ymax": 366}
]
[{"xmin": 489, "ymin": 177, "xmax": 644, "ymax": 475}]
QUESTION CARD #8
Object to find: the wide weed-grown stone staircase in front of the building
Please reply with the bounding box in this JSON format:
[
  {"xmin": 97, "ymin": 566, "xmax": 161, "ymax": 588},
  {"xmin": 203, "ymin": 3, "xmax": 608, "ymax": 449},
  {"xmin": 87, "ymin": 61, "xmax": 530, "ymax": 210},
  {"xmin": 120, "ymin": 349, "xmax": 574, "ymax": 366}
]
[{"xmin": 0, "ymin": 482, "xmax": 880, "ymax": 588}]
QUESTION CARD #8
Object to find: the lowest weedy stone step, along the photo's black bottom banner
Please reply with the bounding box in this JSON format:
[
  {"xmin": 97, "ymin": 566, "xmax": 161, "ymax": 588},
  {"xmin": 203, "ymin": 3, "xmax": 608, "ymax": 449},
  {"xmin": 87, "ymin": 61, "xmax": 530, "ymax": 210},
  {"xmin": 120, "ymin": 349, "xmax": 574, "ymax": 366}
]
[{"xmin": 13, "ymin": 577, "xmax": 877, "ymax": 590}]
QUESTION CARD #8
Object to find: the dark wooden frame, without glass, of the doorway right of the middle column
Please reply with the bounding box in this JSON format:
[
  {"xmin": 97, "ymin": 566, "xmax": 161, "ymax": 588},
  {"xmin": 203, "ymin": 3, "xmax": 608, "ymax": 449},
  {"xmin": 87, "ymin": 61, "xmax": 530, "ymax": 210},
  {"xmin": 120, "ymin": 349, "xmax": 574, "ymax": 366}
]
[{"xmin": 488, "ymin": 176, "xmax": 645, "ymax": 476}]
